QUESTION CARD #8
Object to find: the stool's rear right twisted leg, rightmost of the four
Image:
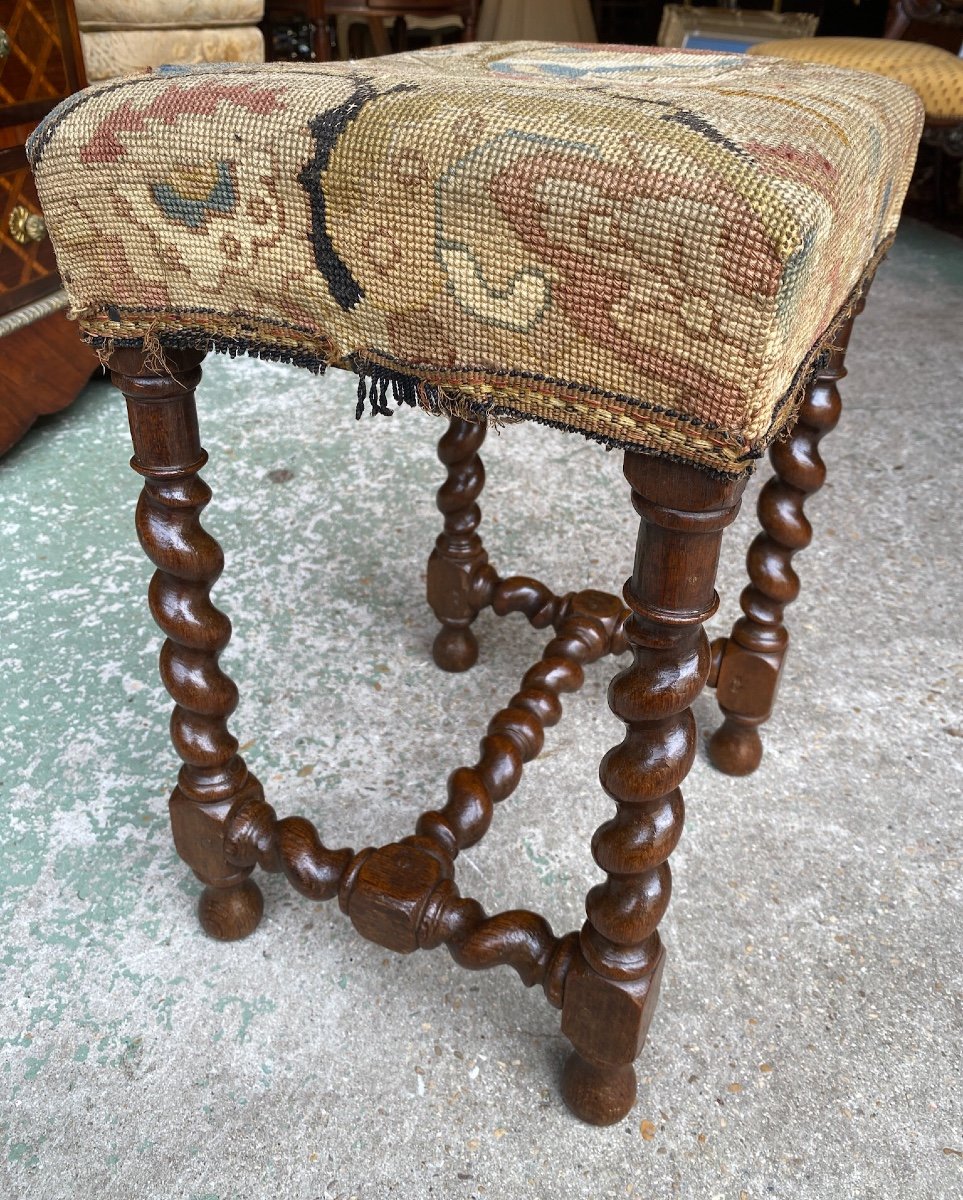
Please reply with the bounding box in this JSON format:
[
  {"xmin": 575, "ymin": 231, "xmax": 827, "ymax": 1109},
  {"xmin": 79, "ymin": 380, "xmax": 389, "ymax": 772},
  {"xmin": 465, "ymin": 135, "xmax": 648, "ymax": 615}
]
[{"xmin": 708, "ymin": 299, "xmax": 865, "ymax": 775}]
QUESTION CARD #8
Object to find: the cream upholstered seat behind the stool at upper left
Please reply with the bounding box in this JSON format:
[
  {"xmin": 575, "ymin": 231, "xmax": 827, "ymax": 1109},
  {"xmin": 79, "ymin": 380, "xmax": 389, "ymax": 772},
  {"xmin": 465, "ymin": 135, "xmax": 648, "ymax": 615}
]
[{"xmin": 74, "ymin": 0, "xmax": 264, "ymax": 83}]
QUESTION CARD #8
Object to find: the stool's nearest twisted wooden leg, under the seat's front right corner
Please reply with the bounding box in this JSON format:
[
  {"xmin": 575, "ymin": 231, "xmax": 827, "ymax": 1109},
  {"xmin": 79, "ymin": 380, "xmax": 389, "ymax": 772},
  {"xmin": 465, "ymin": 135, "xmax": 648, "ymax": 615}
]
[{"xmin": 562, "ymin": 452, "xmax": 744, "ymax": 1124}]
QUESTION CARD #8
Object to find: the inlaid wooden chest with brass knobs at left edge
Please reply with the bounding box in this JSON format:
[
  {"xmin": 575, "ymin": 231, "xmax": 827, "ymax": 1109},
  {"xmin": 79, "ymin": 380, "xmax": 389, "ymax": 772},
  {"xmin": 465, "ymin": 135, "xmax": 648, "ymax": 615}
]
[{"xmin": 0, "ymin": 0, "xmax": 97, "ymax": 454}]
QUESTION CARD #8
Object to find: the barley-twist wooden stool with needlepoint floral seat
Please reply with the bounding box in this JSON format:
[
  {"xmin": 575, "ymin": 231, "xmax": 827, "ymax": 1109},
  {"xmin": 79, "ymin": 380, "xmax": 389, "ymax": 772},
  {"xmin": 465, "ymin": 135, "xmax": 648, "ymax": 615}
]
[{"xmin": 30, "ymin": 43, "xmax": 921, "ymax": 1123}]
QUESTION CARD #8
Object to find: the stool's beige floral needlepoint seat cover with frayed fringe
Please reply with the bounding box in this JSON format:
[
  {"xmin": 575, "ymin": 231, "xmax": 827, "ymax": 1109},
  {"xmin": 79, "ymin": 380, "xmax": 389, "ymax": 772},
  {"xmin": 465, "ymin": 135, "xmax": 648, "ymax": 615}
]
[{"xmin": 30, "ymin": 42, "xmax": 922, "ymax": 474}]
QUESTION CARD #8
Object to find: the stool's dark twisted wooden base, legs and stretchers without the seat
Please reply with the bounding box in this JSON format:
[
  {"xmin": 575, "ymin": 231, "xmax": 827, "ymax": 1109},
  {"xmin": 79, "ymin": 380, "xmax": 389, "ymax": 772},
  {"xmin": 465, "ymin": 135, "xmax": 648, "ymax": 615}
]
[{"xmin": 101, "ymin": 340, "xmax": 849, "ymax": 1124}]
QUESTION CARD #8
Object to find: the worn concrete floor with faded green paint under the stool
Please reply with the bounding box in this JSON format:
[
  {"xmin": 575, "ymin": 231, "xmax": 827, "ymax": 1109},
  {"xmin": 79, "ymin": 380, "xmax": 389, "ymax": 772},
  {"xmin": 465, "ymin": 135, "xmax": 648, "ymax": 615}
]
[{"xmin": 0, "ymin": 223, "xmax": 963, "ymax": 1200}]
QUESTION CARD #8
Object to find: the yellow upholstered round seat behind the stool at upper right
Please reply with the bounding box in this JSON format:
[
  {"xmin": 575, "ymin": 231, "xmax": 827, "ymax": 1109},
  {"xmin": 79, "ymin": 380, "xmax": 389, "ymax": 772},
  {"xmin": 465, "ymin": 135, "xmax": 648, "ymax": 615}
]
[{"xmin": 749, "ymin": 37, "xmax": 963, "ymax": 121}]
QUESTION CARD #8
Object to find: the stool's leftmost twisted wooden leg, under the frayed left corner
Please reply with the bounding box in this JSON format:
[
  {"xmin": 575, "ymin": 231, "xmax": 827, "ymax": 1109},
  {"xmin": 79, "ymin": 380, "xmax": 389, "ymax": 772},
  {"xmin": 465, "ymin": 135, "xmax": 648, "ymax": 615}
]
[{"xmin": 109, "ymin": 350, "xmax": 264, "ymax": 940}]
